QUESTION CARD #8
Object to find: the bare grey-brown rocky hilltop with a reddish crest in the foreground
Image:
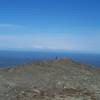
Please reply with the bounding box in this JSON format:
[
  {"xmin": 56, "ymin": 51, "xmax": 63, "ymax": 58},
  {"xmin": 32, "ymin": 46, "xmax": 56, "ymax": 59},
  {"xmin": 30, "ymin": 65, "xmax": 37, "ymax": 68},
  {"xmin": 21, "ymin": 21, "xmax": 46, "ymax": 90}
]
[{"xmin": 0, "ymin": 58, "xmax": 100, "ymax": 100}]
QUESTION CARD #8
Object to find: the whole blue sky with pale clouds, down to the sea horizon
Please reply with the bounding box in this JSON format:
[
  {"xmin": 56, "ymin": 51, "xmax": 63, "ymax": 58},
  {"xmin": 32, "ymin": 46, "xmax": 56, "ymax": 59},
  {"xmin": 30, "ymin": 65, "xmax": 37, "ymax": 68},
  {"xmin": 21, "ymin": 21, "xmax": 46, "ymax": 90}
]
[{"xmin": 0, "ymin": 0, "xmax": 100, "ymax": 53}]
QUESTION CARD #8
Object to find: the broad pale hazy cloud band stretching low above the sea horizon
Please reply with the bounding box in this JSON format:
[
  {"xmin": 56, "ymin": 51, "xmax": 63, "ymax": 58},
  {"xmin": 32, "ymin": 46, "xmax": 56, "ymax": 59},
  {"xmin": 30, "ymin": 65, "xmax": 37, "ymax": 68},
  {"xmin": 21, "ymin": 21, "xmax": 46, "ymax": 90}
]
[{"xmin": 0, "ymin": 34, "xmax": 100, "ymax": 52}]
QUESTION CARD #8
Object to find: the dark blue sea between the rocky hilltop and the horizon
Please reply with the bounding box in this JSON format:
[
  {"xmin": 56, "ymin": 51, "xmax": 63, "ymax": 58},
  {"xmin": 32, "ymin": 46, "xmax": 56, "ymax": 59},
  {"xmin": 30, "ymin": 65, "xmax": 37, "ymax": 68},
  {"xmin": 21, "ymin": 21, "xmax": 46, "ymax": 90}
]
[{"xmin": 0, "ymin": 51, "xmax": 100, "ymax": 67}]
